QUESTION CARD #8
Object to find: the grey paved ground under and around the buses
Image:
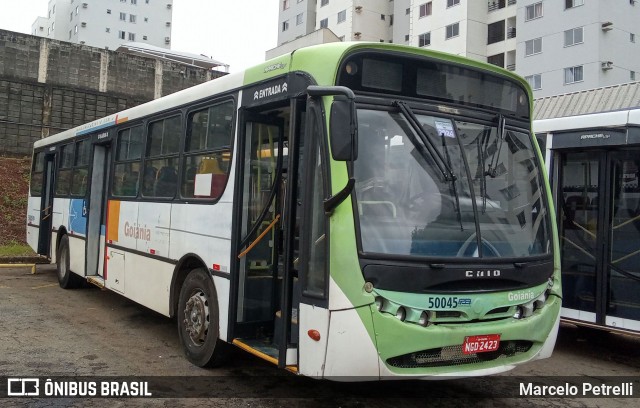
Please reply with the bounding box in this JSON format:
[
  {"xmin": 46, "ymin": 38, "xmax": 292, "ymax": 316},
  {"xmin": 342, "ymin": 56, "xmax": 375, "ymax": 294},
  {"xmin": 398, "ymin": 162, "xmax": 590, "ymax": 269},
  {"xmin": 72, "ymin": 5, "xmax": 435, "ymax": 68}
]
[{"xmin": 0, "ymin": 266, "xmax": 640, "ymax": 408}]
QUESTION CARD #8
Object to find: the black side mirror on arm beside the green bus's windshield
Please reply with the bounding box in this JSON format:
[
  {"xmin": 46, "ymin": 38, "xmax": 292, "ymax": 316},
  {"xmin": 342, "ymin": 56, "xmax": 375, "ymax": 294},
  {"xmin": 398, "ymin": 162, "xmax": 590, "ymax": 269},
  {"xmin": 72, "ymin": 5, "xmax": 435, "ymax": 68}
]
[{"xmin": 307, "ymin": 85, "xmax": 358, "ymax": 161}]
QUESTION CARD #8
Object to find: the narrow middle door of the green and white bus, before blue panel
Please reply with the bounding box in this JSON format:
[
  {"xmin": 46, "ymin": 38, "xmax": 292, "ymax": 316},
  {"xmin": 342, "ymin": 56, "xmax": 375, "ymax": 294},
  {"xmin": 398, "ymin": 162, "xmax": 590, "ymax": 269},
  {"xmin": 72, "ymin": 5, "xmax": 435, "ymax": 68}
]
[{"xmin": 85, "ymin": 144, "xmax": 111, "ymax": 283}]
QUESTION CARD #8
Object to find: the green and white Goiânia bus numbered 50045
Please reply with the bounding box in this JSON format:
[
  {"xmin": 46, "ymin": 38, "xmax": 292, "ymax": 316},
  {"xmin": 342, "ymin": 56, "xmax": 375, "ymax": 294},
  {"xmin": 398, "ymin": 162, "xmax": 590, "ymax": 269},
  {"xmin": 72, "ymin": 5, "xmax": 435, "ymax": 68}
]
[{"xmin": 27, "ymin": 43, "xmax": 561, "ymax": 380}]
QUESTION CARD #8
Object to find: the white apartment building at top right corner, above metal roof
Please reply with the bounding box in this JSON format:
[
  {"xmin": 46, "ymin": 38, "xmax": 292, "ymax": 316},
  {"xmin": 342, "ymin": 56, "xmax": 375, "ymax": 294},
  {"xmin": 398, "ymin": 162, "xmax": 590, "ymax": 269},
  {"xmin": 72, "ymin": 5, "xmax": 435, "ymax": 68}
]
[{"xmin": 516, "ymin": 0, "xmax": 640, "ymax": 98}]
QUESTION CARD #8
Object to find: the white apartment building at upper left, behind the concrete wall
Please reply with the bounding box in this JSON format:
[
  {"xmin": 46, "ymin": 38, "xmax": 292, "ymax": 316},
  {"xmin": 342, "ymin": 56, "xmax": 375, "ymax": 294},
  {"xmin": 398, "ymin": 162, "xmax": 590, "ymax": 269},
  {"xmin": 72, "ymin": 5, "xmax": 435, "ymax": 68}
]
[{"xmin": 31, "ymin": 0, "xmax": 173, "ymax": 50}]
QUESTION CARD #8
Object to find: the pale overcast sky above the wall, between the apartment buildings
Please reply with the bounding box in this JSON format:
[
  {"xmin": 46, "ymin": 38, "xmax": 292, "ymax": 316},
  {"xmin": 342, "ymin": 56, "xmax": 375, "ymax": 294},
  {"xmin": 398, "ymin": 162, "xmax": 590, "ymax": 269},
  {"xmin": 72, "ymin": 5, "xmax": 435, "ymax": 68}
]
[{"xmin": 0, "ymin": 0, "xmax": 280, "ymax": 72}]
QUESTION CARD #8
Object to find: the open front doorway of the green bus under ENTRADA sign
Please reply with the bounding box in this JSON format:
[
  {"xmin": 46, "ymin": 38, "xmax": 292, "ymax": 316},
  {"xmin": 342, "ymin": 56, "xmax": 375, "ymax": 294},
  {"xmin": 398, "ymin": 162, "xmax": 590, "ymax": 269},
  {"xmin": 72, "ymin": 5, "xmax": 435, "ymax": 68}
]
[{"xmin": 231, "ymin": 112, "xmax": 286, "ymax": 348}]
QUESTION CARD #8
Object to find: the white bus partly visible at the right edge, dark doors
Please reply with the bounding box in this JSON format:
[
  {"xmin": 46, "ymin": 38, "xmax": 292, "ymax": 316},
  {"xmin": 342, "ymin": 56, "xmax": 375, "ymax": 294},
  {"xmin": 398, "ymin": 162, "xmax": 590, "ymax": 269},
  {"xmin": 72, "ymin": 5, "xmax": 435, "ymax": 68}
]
[{"xmin": 534, "ymin": 109, "xmax": 640, "ymax": 334}]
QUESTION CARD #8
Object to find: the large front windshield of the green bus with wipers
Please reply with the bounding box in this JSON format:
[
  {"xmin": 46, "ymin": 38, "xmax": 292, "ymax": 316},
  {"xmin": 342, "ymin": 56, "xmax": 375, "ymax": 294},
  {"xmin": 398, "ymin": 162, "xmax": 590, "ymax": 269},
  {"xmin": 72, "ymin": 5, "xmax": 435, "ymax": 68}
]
[{"xmin": 354, "ymin": 109, "xmax": 551, "ymax": 258}]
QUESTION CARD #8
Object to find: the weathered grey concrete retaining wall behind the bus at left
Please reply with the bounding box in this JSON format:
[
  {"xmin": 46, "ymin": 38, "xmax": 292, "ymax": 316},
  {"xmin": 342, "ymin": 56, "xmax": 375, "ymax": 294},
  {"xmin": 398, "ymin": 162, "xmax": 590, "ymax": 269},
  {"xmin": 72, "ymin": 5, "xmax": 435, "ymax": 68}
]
[{"xmin": 0, "ymin": 30, "xmax": 224, "ymax": 155}]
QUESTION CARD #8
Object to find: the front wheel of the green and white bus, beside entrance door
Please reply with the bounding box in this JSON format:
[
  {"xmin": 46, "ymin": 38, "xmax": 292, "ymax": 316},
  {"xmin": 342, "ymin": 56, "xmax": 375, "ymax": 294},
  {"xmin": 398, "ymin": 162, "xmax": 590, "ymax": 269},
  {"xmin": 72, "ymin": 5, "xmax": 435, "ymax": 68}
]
[{"xmin": 176, "ymin": 268, "xmax": 224, "ymax": 367}]
